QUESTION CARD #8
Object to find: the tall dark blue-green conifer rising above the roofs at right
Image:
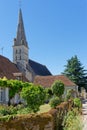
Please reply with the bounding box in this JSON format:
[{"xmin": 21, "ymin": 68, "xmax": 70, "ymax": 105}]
[{"xmin": 63, "ymin": 55, "xmax": 87, "ymax": 91}]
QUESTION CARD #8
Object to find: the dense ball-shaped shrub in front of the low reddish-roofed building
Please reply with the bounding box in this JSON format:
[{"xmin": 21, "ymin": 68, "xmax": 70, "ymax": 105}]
[{"xmin": 52, "ymin": 80, "xmax": 64, "ymax": 97}]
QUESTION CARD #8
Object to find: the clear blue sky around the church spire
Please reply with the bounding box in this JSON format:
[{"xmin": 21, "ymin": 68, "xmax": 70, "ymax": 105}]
[{"xmin": 0, "ymin": 0, "xmax": 87, "ymax": 75}]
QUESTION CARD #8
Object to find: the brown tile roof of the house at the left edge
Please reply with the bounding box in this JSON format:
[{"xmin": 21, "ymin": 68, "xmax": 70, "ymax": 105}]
[{"xmin": 0, "ymin": 55, "xmax": 27, "ymax": 81}]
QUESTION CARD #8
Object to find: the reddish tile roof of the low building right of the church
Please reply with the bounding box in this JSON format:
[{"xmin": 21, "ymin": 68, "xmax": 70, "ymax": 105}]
[{"xmin": 34, "ymin": 75, "xmax": 77, "ymax": 87}]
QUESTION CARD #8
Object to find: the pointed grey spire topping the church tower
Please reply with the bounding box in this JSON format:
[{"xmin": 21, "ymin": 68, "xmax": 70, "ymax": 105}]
[{"xmin": 14, "ymin": 9, "xmax": 28, "ymax": 47}]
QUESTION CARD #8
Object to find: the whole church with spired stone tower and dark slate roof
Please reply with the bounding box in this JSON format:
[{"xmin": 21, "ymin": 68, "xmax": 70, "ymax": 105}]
[{"xmin": 13, "ymin": 9, "xmax": 52, "ymax": 82}]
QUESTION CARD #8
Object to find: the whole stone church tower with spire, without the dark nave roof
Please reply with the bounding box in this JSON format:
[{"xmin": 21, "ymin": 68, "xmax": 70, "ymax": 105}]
[{"xmin": 13, "ymin": 9, "xmax": 32, "ymax": 81}]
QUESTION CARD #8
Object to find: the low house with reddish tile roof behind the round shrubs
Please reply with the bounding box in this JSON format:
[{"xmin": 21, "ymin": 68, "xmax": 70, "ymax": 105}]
[{"xmin": 34, "ymin": 75, "xmax": 78, "ymax": 96}]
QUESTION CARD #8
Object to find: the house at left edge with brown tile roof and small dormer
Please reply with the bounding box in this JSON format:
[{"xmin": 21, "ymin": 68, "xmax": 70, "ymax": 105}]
[{"xmin": 0, "ymin": 55, "xmax": 28, "ymax": 104}]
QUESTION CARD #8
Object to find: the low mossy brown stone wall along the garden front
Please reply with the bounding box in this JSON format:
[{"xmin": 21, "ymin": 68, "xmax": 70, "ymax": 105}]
[{"xmin": 0, "ymin": 101, "xmax": 72, "ymax": 130}]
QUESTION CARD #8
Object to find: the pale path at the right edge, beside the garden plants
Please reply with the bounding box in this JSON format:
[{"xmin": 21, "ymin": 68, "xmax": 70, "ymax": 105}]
[{"xmin": 82, "ymin": 99, "xmax": 87, "ymax": 130}]
